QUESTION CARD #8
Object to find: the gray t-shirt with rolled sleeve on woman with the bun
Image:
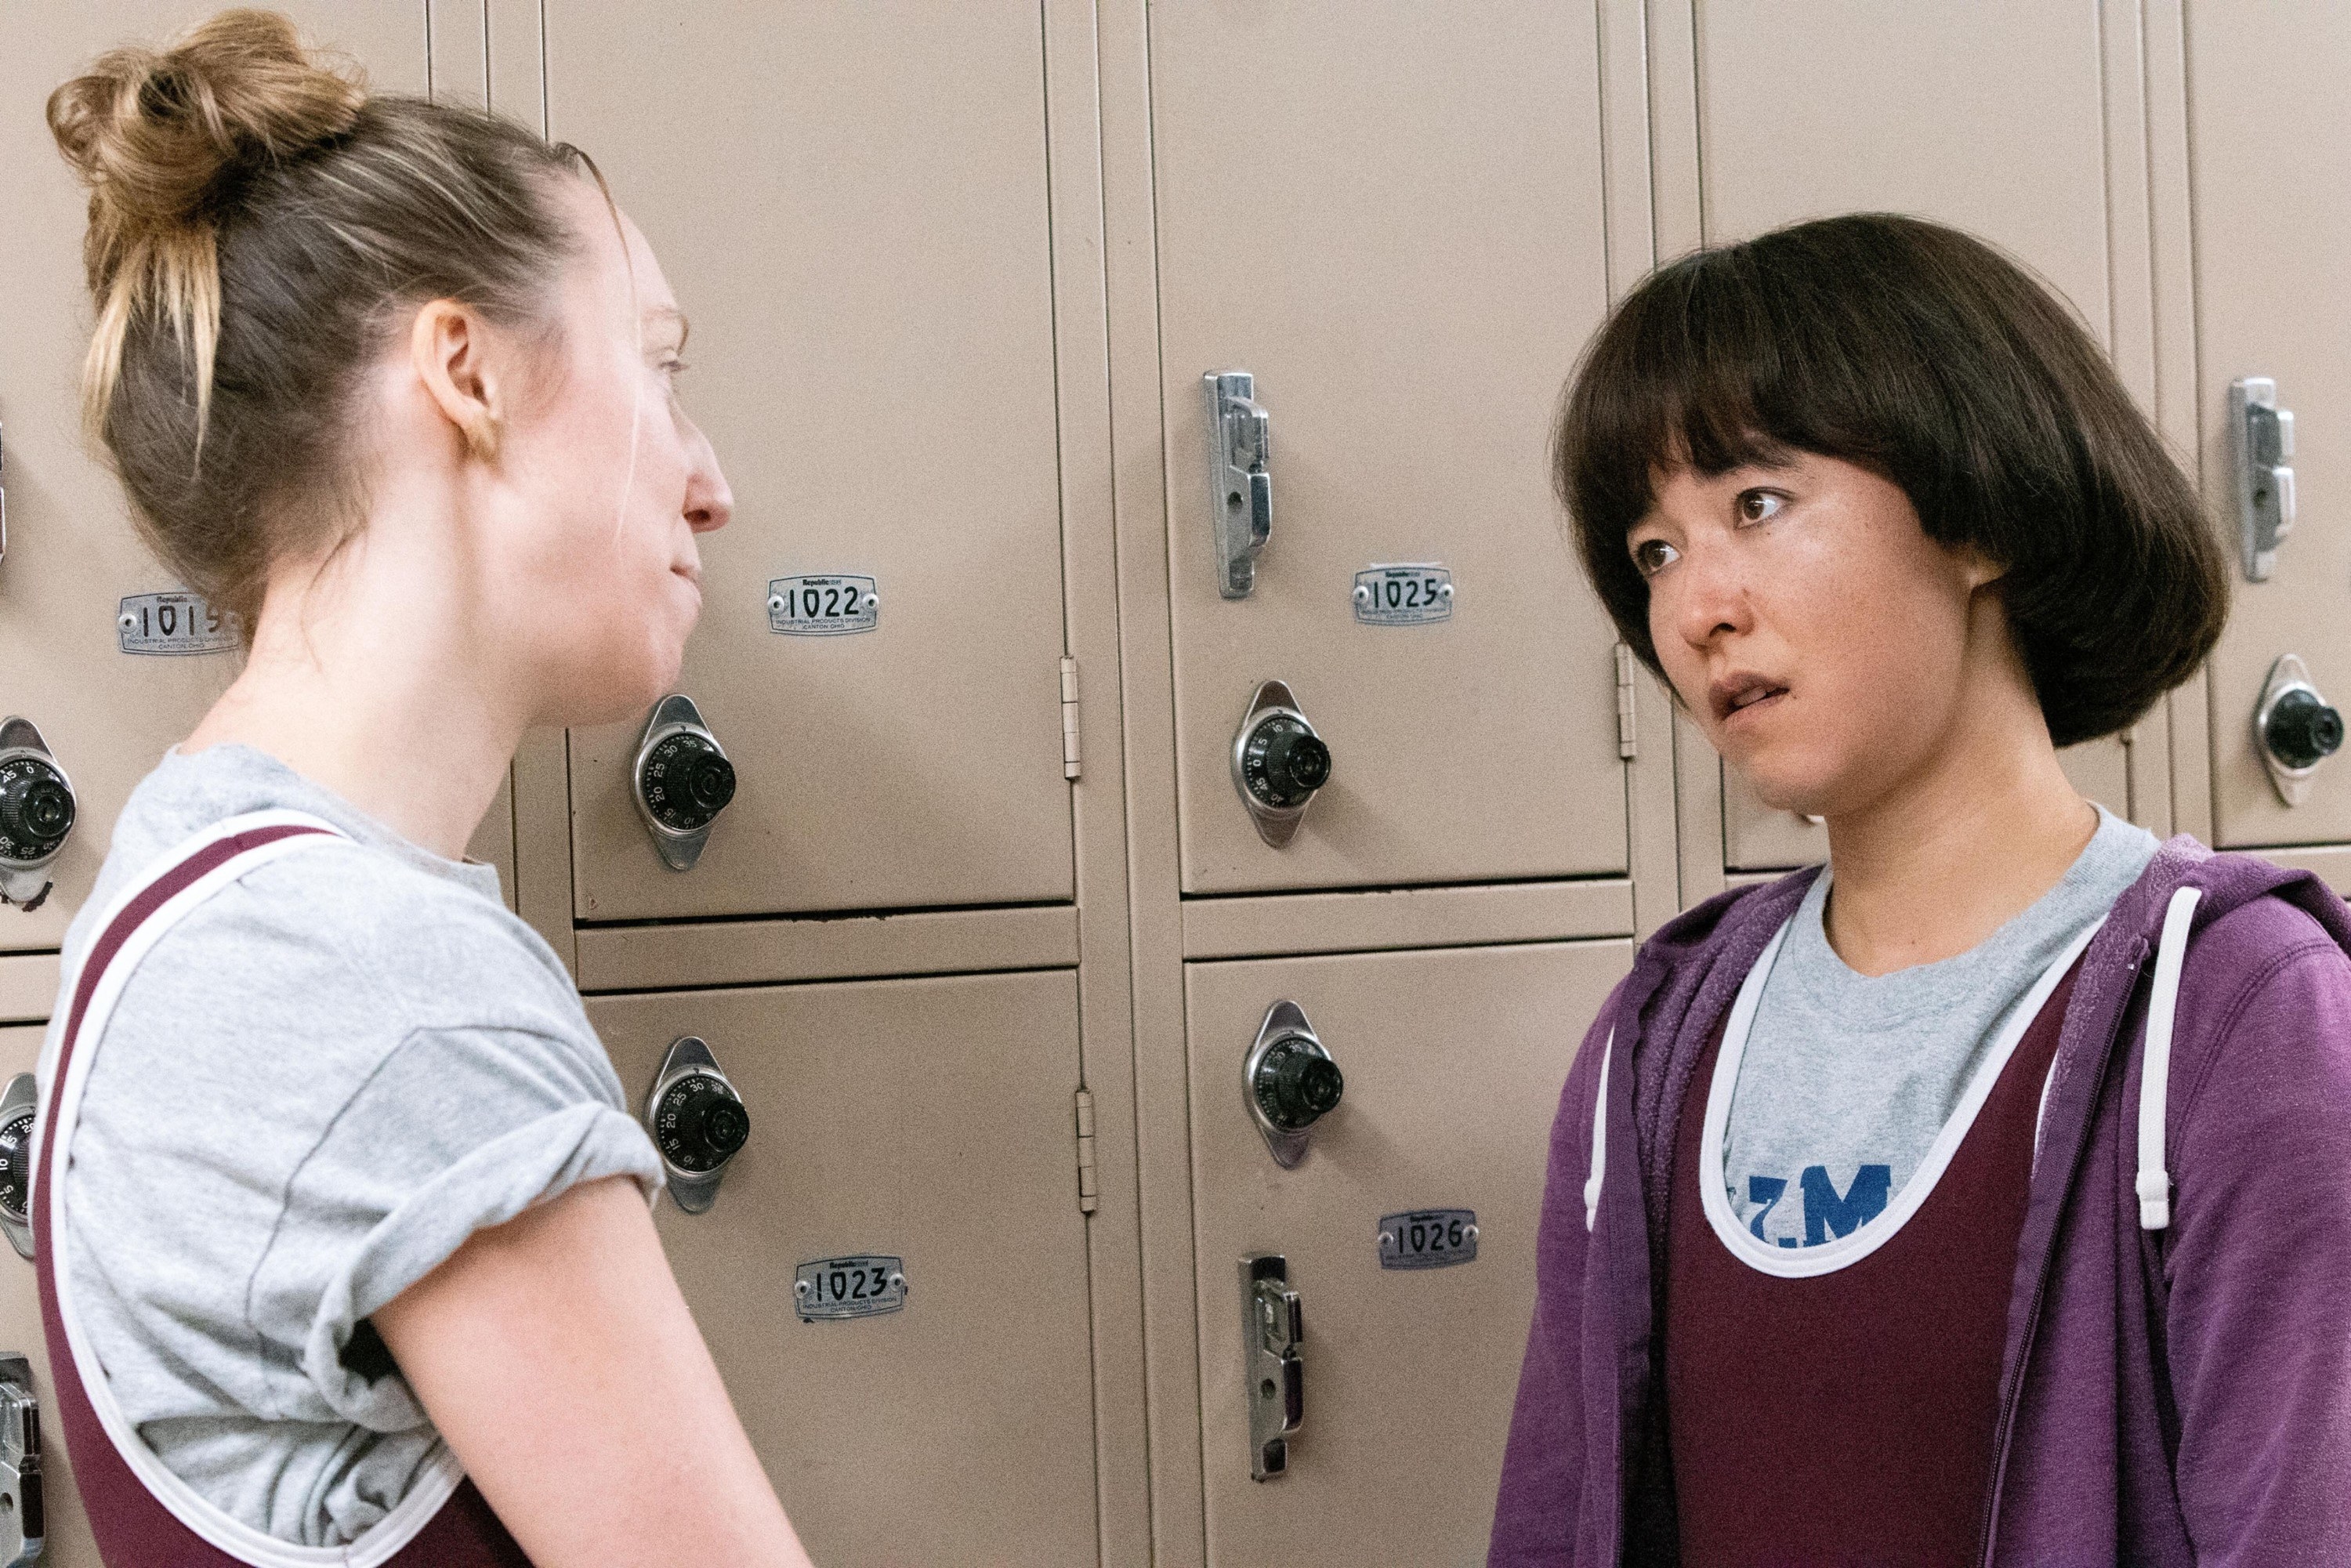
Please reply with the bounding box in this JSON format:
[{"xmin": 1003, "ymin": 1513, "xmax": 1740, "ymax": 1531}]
[{"xmin": 52, "ymin": 745, "xmax": 661, "ymax": 1547}]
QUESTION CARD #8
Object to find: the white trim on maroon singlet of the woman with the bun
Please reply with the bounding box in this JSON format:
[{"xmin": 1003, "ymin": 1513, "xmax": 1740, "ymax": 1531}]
[{"xmin": 33, "ymin": 811, "xmax": 465, "ymax": 1568}]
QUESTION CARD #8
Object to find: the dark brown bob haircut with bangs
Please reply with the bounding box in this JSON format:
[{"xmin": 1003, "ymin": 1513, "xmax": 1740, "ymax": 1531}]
[{"xmin": 1554, "ymin": 212, "xmax": 2229, "ymax": 745}]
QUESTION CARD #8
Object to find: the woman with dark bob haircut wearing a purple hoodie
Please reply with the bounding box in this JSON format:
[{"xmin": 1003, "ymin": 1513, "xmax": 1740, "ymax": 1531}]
[{"xmin": 1491, "ymin": 216, "xmax": 2351, "ymax": 1568}]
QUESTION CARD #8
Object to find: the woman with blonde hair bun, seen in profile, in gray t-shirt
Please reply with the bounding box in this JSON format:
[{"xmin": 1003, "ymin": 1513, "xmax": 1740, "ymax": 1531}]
[{"xmin": 35, "ymin": 12, "xmax": 806, "ymax": 1568}]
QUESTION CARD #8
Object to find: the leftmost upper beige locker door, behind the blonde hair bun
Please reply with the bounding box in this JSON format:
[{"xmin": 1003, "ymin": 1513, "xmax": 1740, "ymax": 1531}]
[{"xmin": 0, "ymin": 0, "xmax": 426, "ymax": 952}]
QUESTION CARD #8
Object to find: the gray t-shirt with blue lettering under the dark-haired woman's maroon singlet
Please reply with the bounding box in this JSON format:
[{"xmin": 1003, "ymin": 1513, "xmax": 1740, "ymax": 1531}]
[{"xmin": 1723, "ymin": 809, "xmax": 2156, "ymax": 1248}]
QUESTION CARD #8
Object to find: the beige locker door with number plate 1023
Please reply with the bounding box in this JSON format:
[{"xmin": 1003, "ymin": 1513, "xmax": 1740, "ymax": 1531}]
[{"xmin": 588, "ymin": 971, "xmax": 1096, "ymax": 1568}]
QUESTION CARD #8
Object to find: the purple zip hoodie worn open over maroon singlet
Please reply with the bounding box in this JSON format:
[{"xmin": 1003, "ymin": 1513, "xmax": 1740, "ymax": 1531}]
[{"xmin": 1488, "ymin": 837, "xmax": 2351, "ymax": 1568}]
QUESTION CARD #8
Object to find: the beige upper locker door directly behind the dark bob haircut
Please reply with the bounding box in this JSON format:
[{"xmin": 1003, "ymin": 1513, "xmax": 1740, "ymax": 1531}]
[{"xmin": 1697, "ymin": 0, "xmax": 2144, "ymax": 867}]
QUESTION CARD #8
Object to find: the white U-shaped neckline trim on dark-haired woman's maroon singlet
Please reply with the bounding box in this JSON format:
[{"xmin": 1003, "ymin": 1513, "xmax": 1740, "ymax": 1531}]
[{"xmin": 1697, "ymin": 917, "xmax": 2106, "ymax": 1279}]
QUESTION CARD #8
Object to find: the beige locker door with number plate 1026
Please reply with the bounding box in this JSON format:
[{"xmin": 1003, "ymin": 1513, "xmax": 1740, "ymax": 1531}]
[{"xmin": 1185, "ymin": 943, "xmax": 1632, "ymax": 1568}]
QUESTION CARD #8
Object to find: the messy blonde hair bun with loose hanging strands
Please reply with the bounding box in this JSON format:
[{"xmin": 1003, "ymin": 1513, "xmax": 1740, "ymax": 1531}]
[{"xmin": 49, "ymin": 9, "xmax": 367, "ymax": 442}]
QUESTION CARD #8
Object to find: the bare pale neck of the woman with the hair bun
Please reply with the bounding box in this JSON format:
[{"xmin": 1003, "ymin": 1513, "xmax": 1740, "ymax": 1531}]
[{"xmin": 181, "ymin": 517, "xmax": 529, "ymax": 860}]
